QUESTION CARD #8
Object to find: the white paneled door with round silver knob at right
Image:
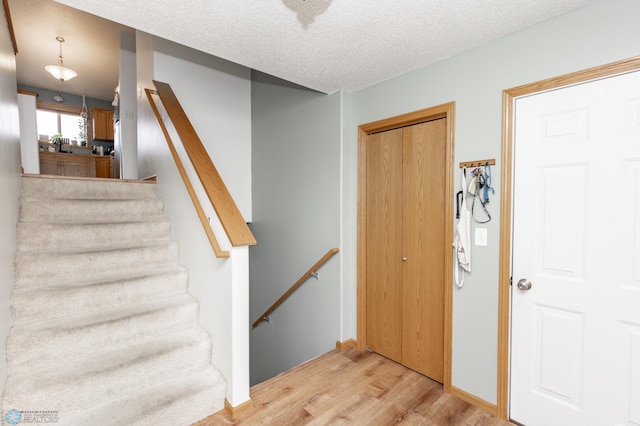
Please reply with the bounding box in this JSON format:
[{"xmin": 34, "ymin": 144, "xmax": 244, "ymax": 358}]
[{"xmin": 510, "ymin": 72, "xmax": 640, "ymax": 426}]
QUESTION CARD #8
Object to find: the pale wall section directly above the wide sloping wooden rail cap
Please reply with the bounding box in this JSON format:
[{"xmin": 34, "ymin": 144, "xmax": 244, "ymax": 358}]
[{"xmin": 145, "ymin": 38, "xmax": 253, "ymax": 222}]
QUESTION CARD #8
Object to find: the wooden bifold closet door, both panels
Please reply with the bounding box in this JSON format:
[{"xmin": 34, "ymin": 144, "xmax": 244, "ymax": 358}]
[{"xmin": 366, "ymin": 118, "xmax": 446, "ymax": 382}]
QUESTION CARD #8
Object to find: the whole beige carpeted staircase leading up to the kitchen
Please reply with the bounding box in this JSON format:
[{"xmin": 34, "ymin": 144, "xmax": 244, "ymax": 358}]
[{"xmin": 2, "ymin": 176, "xmax": 226, "ymax": 426}]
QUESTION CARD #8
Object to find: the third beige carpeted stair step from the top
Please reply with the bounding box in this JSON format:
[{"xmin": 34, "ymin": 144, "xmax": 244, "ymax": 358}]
[{"xmin": 16, "ymin": 219, "xmax": 171, "ymax": 251}]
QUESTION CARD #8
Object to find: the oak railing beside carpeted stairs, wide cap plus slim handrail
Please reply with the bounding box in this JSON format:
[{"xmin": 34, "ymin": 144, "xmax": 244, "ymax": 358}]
[{"xmin": 145, "ymin": 80, "xmax": 256, "ymax": 257}]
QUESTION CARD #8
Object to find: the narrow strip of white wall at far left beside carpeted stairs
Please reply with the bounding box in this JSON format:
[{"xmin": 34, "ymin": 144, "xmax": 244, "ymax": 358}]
[{"xmin": 0, "ymin": 11, "xmax": 22, "ymax": 394}]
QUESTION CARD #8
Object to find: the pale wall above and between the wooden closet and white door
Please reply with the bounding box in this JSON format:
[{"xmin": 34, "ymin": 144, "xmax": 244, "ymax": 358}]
[{"xmin": 343, "ymin": 0, "xmax": 640, "ymax": 403}]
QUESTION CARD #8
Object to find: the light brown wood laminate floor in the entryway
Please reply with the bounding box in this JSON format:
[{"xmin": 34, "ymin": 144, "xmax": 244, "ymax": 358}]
[{"xmin": 195, "ymin": 349, "xmax": 510, "ymax": 426}]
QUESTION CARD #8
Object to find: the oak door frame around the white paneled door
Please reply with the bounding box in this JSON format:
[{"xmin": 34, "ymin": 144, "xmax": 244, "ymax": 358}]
[{"xmin": 497, "ymin": 56, "xmax": 640, "ymax": 420}]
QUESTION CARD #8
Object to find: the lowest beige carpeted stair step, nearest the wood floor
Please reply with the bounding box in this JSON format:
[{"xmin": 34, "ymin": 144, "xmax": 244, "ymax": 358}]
[{"xmin": 59, "ymin": 365, "xmax": 226, "ymax": 426}]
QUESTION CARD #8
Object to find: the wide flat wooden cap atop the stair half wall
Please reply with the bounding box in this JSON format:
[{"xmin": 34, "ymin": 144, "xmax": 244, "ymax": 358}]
[{"xmin": 153, "ymin": 80, "xmax": 256, "ymax": 247}]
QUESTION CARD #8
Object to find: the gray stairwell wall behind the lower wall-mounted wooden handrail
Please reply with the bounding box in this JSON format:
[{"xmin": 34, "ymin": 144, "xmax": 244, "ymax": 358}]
[{"xmin": 249, "ymin": 72, "xmax": 341, "ymax": 384}]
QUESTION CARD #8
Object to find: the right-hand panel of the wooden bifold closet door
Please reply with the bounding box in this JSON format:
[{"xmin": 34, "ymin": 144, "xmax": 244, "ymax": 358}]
[{"xmin": 402, "ymin": 119, "xmax": 446, "ymax": 382}]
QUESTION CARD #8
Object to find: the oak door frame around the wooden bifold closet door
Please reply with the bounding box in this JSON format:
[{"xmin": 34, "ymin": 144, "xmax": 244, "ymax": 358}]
[{"xmin": 357, "ymin": 102, "xmax": 455, "ymax": 392}]
